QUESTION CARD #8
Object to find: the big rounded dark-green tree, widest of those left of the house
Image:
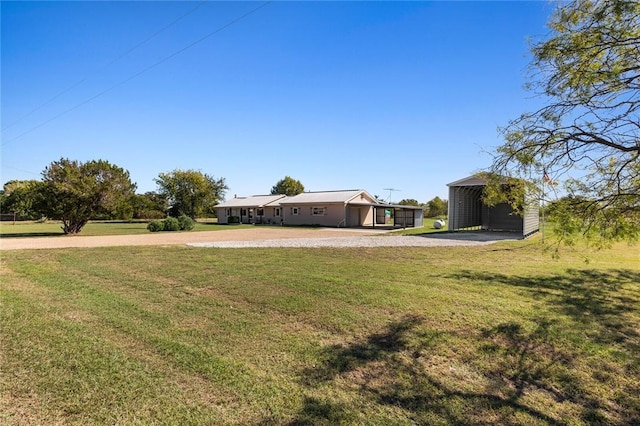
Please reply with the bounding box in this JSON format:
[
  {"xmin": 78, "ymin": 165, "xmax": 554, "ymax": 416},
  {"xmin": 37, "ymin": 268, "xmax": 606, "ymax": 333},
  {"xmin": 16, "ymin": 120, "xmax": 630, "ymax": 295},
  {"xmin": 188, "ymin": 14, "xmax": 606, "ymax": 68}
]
[{"xmin": 38, "ymin": 158, "xmax": 136, "ymax": 234}]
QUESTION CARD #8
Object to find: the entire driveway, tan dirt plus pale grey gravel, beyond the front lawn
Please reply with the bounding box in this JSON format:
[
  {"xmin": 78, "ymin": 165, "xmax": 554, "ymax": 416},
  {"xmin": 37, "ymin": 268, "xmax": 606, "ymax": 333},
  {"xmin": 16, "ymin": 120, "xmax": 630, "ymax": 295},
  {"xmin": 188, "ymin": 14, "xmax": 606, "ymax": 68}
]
[{"xmin": 0, "ymin": 226, "xmax": 514, "ymax": 250}]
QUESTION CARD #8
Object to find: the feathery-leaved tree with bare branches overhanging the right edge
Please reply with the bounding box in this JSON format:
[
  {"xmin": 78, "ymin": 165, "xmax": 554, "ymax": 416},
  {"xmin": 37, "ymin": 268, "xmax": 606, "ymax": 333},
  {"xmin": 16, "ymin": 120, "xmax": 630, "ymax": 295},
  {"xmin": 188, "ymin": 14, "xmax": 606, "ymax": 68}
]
[{"xmin": 493, "ymin": 0, "xmax": 640, "ymax": 245}]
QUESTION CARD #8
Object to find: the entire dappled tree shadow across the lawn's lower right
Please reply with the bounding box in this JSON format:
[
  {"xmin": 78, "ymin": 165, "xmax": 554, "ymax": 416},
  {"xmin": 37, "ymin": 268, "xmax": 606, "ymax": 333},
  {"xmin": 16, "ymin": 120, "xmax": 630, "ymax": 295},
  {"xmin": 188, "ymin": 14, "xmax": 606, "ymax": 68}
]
[{"xmin": 289, "ymin": 270, "xmax": 640, "ymax": 425}]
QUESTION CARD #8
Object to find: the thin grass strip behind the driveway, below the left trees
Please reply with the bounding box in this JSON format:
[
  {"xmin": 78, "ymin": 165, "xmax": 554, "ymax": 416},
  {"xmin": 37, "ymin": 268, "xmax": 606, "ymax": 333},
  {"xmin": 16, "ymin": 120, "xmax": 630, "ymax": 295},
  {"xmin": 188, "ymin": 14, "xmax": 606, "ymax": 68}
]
[{"xmin": 0, "ymin": 220, "xmax": 253, "ymax": 238}]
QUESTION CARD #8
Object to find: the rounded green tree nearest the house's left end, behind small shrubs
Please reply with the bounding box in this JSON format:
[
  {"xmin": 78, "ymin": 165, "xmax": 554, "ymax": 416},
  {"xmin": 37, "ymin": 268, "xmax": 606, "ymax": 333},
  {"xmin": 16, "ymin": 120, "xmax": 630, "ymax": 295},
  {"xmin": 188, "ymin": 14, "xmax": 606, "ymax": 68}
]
[{"xmin": 155, "ymin": 169, "xmax": 229, "ymax": 219}]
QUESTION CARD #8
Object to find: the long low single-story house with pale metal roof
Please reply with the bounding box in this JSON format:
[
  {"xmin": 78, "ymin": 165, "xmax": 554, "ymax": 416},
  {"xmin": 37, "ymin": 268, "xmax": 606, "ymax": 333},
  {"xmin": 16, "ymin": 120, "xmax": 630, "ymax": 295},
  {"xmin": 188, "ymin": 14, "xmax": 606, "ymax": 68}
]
[{"xmin": 216, "ymin": 189, "xmax": 423, "ymax": 228}]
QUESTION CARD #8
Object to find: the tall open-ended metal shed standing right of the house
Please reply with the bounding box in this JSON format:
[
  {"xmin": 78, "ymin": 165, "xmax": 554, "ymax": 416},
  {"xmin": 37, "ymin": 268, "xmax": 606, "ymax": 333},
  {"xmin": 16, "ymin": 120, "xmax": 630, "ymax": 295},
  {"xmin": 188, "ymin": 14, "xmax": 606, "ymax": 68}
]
[{"xmin": 447, "ymin": 175, "xmax": 540, "ymax": 238}]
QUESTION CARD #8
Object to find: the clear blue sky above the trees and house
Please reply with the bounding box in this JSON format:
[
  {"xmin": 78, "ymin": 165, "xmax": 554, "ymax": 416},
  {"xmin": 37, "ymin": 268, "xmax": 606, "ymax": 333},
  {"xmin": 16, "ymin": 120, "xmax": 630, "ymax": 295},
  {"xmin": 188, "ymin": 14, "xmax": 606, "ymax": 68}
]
[{"xmin": 0, "ymin": 1, "xmax": 553, "ymax": 202}]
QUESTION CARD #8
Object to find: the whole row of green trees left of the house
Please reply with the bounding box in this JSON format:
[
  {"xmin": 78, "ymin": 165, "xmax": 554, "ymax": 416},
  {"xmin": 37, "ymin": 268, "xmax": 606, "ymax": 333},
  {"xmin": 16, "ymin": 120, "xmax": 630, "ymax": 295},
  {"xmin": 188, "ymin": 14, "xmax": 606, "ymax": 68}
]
[{"xmin": 0, "ymin": 158, "xmax": 228, "ymax": 234}]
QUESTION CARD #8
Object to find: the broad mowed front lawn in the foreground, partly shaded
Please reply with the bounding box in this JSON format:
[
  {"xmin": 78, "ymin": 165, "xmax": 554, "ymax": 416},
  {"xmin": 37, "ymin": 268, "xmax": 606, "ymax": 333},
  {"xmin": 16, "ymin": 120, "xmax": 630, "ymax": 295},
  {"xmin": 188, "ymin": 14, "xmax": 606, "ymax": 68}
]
[{"xmin": 0, "ymin": 238, "xmax": 640, "ymax": 425}]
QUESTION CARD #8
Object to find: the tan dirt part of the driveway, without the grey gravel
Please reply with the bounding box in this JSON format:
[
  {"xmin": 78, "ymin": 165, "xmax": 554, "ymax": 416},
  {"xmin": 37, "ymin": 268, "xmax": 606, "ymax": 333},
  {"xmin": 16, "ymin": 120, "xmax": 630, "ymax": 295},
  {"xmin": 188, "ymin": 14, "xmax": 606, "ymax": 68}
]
[{"xmin": 0, "ymin": 226, "xmax": 388, "ymax": 250}]
